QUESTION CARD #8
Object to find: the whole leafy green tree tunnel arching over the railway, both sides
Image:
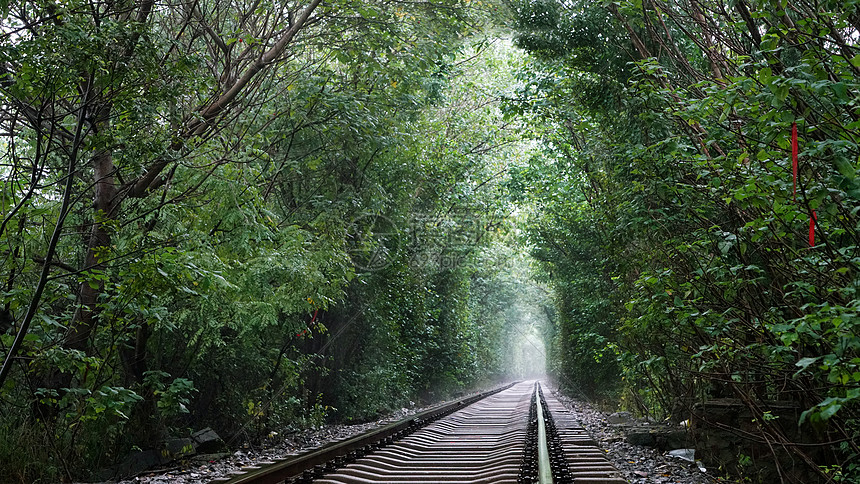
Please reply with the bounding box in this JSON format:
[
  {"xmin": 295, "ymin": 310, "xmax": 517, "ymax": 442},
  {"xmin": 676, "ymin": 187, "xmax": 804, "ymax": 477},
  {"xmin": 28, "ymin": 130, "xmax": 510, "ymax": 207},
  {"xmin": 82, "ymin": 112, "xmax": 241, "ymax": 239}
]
[{"xmin": 0, "ymin": 0, "xmax": 860, "ymax": 482}]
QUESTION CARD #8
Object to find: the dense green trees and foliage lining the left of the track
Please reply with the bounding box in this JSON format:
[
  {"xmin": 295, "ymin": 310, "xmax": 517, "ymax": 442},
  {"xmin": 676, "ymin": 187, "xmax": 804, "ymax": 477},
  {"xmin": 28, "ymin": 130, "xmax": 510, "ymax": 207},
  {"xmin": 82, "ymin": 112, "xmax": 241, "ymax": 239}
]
[{"xmin": 0, "ymin": 0, "xmax": 536, "ymax": 482}]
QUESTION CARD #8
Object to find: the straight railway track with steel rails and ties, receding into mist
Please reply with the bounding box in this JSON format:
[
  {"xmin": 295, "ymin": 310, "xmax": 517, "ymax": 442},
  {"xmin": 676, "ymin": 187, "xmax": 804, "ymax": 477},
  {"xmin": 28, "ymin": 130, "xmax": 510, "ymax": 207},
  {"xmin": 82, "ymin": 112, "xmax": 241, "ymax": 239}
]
[{"xmin": 211, "ymin": 382, "xmax": 627, "ymax": 484}]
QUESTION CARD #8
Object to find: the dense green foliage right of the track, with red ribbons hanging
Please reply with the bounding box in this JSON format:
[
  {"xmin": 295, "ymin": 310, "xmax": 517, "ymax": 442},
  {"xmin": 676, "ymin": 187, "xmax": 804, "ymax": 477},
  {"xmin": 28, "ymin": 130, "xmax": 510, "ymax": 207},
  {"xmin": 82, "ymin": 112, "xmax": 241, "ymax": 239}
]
[{"xmin": 510, "ymin": 0, "xmax": 860, "ymax": 479}]
